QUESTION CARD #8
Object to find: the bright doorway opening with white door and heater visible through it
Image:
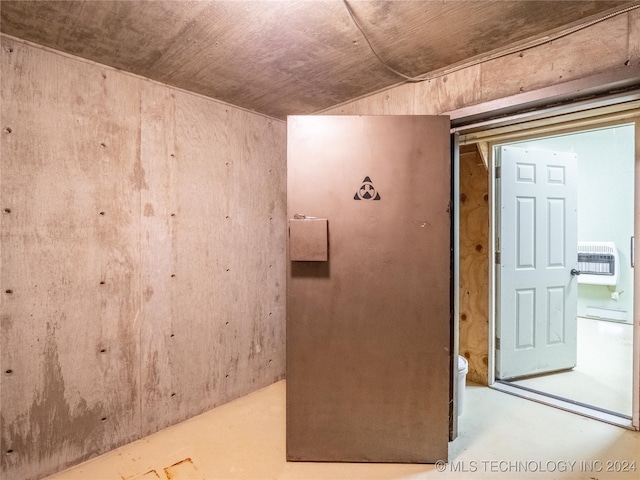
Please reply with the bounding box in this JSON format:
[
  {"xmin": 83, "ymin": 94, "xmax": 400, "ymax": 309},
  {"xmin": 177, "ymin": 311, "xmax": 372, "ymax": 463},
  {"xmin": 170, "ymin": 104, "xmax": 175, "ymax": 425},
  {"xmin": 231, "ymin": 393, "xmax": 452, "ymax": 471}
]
[{"xmin": 489, "ymin": 120, "xmax": 638, "ymax": 427}]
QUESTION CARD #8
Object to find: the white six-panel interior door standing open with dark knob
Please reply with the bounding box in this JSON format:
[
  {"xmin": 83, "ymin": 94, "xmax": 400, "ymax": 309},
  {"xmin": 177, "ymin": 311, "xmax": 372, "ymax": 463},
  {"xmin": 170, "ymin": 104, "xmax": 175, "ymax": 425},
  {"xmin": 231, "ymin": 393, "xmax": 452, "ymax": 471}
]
[{"xmin": 496, "ymin": 146, "xmax": 578, "ymax": 379}]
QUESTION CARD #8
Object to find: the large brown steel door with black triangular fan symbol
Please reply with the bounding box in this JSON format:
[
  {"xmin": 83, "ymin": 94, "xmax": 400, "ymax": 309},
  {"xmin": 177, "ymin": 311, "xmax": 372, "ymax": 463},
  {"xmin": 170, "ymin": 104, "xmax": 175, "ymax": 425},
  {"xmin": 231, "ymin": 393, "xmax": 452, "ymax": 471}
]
[{"xmin": 287, "ymin": 116, "xmax": 452, "ymax": 463}]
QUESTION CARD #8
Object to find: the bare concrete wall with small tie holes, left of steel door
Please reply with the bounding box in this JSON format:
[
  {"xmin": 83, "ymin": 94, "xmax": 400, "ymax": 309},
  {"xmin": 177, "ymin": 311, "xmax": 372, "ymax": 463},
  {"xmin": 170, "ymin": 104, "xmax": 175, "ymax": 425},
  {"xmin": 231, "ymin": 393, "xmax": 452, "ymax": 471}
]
[{"xmin": 0, "ymin": 37, "xmax": 286, "ymax": 480}]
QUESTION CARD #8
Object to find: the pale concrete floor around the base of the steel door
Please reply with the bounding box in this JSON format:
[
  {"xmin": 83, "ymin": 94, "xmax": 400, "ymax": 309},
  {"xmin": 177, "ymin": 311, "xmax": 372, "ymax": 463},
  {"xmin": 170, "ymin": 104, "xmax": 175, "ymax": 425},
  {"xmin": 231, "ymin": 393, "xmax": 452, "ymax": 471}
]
[{"xmin": 49, "ymin": 381, "xmax": 640, "ymax": 480}]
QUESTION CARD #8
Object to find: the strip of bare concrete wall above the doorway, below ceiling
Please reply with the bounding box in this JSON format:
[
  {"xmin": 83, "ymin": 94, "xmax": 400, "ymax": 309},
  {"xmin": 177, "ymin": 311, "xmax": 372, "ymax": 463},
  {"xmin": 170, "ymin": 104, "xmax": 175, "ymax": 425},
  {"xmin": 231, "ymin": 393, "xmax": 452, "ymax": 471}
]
[{"xmin": 321, "ymin": 9, "xmax": 640, "ymax": 115}]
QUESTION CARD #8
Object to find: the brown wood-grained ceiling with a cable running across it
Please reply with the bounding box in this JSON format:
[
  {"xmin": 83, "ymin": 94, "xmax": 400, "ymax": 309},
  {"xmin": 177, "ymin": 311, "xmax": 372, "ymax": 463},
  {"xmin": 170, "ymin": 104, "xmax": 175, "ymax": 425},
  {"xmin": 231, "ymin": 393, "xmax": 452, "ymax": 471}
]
[{"xmin": 0, "ymin": 0, "xmax": 638, "ymax": 118}]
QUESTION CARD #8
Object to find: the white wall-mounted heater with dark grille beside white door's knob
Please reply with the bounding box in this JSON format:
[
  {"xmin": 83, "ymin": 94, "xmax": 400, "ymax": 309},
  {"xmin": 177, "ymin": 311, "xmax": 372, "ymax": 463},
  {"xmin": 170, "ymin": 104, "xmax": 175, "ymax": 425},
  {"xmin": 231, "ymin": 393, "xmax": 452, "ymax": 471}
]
[{"xmin": 578, "ymin": 242, "xmax": 620, "ymax": 285}]
